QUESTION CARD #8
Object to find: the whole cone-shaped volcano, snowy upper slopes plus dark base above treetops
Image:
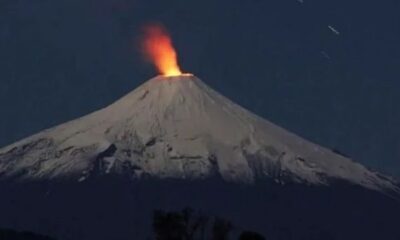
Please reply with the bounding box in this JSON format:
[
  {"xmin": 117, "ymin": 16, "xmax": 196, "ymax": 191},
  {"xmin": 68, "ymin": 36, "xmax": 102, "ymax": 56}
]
[{"xmin": 0, "ymin": 74, "xmax": 400, "ymax": 239}]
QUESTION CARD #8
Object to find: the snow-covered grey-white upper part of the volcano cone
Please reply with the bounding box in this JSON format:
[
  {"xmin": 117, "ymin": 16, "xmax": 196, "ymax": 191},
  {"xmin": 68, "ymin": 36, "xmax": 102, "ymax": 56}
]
[{"xmin": 0, "ymin": 75, "xmax": 398, "ymax": 191}]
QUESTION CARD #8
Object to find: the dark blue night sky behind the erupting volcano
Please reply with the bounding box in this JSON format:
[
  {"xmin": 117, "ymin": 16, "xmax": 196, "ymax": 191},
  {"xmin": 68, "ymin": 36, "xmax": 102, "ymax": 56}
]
[{"xmin": 0, "ymin": 0, "xmax": 400, "ymax": 177}]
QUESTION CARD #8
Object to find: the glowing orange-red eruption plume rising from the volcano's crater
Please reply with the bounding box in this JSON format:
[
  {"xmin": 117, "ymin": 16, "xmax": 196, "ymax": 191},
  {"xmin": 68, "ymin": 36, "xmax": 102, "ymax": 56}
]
[{"xmin": 142, "ymin": 25, "xmax": 182, "ymax": 76}]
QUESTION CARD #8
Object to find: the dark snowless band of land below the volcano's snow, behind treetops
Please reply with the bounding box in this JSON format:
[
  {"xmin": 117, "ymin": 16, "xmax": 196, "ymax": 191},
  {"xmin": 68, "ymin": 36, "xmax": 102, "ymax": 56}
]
[{"xmin": 0, "ymin": 177, "xmax": 400, "ymax": 240}]
